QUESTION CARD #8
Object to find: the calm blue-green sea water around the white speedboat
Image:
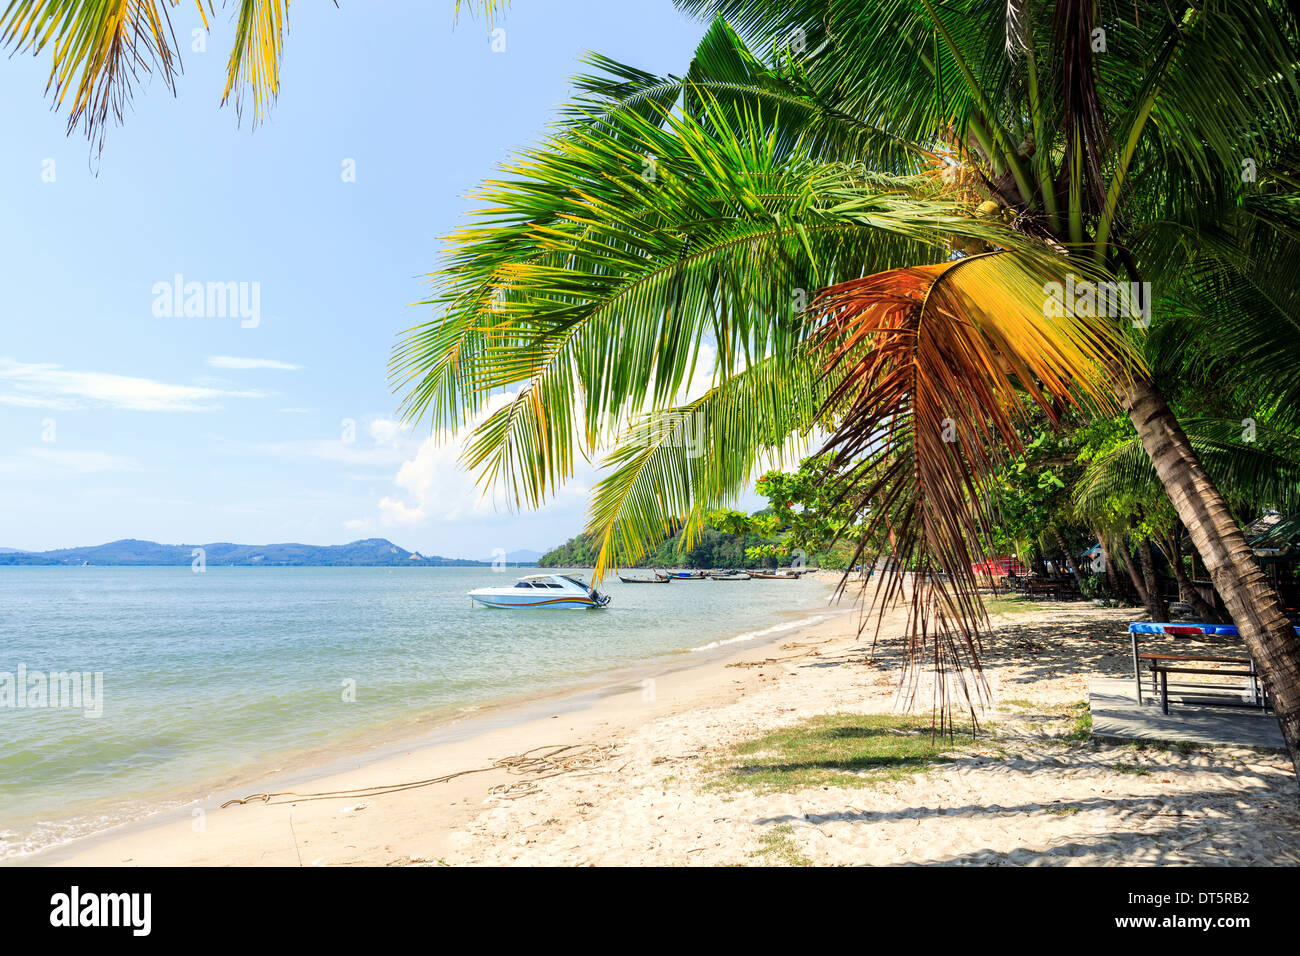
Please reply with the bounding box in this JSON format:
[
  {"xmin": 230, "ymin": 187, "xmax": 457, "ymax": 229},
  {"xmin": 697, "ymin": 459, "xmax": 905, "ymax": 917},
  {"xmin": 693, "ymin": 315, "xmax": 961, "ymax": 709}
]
[{"xmin": 0, "ymin": 566, "xmax": 829, "ymax": 858}]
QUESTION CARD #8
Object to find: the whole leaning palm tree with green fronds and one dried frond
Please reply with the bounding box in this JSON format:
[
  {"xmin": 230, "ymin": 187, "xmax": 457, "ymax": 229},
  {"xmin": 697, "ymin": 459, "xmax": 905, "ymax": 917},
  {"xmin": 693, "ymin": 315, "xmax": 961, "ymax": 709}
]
[{"xmin": 394, "ymin": 0, "xmax": 1300, "ymax": 770}]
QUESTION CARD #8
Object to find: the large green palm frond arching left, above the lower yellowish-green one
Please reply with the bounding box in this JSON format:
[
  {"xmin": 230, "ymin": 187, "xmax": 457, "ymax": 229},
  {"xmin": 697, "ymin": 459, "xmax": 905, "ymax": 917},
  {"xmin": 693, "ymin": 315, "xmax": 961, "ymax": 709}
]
[{"xmin": 394, "ymin": 89, "xmax": 1023, "ymax": 505}]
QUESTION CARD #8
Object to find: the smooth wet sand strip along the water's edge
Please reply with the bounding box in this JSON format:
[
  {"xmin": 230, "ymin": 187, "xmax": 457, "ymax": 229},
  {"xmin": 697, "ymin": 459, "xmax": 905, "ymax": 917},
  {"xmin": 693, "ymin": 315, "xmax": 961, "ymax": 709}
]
[{"xmin": 10, "ymin": 572, "xmax": 853, "ymax": 866}]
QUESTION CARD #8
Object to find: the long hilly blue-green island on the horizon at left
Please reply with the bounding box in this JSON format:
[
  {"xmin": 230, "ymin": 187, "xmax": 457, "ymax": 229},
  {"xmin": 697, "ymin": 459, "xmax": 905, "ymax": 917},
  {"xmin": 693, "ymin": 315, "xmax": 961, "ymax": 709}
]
[{"xmin": 0, "ymin": 537, "xmax": 538, "ymax": 567}]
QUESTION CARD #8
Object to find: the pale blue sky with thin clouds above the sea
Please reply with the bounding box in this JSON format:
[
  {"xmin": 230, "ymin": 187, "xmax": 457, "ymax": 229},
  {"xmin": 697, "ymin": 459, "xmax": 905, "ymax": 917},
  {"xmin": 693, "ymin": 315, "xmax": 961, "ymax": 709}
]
[{"xmin": 0, "ymin": 0, "xmax": 705, "ymax": 557}]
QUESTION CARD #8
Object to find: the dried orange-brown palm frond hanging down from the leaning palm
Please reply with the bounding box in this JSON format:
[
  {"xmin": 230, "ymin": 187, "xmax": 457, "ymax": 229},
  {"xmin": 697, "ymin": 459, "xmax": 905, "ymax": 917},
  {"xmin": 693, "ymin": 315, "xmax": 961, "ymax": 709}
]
[{"xmin": 813, "ymin": 252, "xmax": 1139, "ymax": 730}]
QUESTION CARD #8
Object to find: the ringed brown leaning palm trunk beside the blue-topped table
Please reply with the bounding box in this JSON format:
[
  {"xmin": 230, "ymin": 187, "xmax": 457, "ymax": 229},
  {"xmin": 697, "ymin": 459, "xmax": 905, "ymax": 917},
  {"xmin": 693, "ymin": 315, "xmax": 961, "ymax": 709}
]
[{"xmin": 1121, "ymin": 378, "xmax": 1300, "ymax": 777}]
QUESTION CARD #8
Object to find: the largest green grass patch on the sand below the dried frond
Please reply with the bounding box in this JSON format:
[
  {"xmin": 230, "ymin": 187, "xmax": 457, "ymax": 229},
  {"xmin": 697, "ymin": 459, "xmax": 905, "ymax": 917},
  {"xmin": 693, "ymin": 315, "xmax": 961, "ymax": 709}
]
[{"xmin": 712, "ymin": 714, "xmax": 980, "ymax": 793}]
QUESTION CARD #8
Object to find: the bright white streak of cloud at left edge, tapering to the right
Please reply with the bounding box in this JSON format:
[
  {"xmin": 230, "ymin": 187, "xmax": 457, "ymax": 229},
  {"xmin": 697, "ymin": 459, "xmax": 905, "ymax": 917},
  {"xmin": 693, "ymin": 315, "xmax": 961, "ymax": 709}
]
[{"xmin": 0, "ymin": 359, "xmax": 263, "ymax": 411}]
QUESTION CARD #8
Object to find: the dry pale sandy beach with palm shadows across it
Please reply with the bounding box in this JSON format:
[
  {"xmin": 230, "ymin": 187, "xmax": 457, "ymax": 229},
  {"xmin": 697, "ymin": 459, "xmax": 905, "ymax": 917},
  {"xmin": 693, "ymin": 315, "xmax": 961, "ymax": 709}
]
[{"xmin": 27, "ymin": 580, "xmax": 1300, "ymax": 866}]
